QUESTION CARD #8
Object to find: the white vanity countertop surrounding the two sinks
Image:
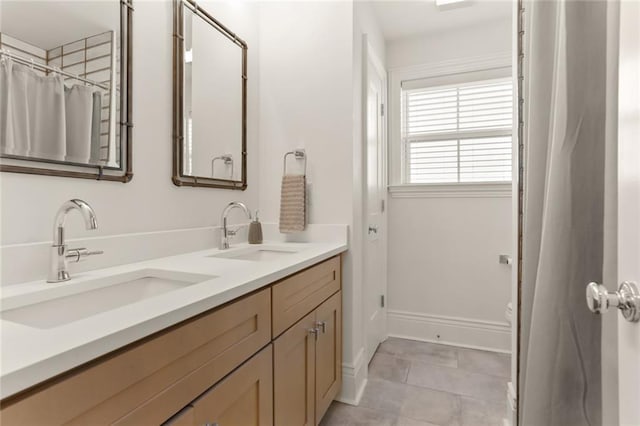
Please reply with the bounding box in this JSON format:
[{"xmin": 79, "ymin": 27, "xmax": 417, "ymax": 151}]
[{"xmin": 0, "ymin": 241, "xmax": 347, "ymax": 398}]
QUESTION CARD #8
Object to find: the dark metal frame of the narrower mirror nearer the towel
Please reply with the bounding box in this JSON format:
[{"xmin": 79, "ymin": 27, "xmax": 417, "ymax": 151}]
[{"xmin": 173, "ymin": 0, "xmax": 247, "ymax": 191}]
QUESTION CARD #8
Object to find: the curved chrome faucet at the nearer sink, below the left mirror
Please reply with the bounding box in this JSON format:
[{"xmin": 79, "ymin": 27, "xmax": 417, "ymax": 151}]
[{"xmin": 47, "ymin": 199, "xmax": 103, "ymax": 283}]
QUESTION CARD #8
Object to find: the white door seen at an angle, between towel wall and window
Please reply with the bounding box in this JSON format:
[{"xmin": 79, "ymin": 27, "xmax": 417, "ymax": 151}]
[{"xmin": 363, "ymin": 37, "xmax": 387, "ymax": 361}]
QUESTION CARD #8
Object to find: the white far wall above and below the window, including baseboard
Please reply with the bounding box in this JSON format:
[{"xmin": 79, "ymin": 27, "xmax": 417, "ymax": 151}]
[{"xmin": 387, "ymin": 20, "xmax": 512, "ymax": 351}]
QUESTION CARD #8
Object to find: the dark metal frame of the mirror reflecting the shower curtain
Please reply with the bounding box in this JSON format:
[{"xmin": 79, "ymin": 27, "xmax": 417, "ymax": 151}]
[{"xmin": 0, "ymin": 0, "xmax": 133, "ymax": 183}]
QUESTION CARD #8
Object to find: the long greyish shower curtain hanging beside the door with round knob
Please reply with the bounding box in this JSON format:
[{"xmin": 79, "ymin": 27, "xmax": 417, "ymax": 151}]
[{"xmin": 519, "ymin": 0, "xmax": 606, "ymax": 426}]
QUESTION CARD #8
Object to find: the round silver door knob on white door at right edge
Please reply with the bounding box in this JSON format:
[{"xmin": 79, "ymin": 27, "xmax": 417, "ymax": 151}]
[{"xmin": 587, "ymin": 281, "xmax": 640, "ymax": 322}]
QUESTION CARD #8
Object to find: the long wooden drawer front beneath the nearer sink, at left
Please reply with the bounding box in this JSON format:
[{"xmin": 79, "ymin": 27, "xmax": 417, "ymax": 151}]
[{"xmin": 0, "ymin": 289, "xmax": 271, "ymax": 425}]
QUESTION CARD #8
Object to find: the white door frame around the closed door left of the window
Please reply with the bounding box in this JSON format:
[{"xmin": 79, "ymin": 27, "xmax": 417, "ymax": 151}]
[{"xmin": 361, "ymin": 34, "xmax": 388, "ymax": 362}]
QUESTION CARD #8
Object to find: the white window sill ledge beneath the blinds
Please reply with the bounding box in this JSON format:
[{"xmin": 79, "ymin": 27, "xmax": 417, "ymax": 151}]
[{"xmin": 389, "ymin": 182, "xmax": 511, "ymax": 198}]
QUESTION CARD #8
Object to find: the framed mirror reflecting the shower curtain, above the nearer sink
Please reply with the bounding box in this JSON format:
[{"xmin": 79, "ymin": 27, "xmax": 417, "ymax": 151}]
[{"xmin": 0, "ymin": 0, "xmax": 133, "ymax": 182}]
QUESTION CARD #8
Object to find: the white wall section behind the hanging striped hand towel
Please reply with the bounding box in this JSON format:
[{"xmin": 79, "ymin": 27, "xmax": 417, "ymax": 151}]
[{"xmin": 260, "ymin": 1, "xmax": 362, "ymax": 402}]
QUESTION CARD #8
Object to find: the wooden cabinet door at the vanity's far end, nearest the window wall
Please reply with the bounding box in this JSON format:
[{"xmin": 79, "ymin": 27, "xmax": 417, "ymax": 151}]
[{"xmin": 315, "ymin": 291, "xmax": 342, "ymax": 424}]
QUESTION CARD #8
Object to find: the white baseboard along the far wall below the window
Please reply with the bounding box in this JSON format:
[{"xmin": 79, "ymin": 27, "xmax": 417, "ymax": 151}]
[{"xmin": 387, "ymin": 310, "xmax": 511, "ymax": 353}]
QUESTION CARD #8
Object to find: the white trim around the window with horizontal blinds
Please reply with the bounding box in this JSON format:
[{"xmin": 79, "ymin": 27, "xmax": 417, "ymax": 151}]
[{"xmin": 388, "ymin": 52, "xmax": 515, "ymax": 191}]
